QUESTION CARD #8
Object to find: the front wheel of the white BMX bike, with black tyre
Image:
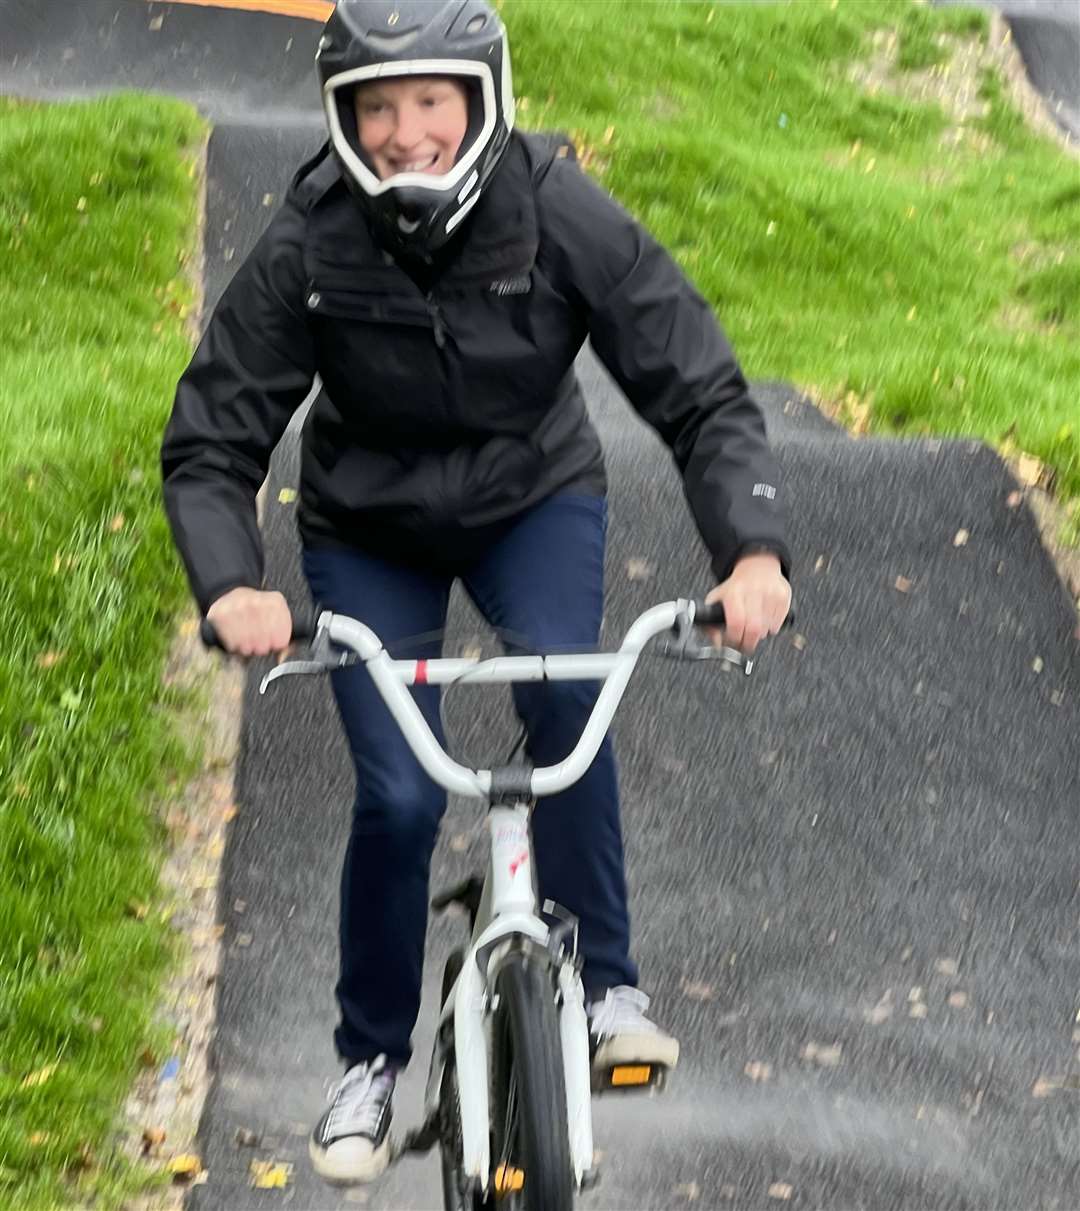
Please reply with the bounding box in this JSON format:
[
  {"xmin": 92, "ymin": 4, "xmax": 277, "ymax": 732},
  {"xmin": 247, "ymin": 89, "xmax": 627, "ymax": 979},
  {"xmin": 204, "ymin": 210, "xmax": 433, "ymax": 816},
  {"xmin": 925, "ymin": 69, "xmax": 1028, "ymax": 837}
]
[{"xmin": 490, "ymin": 952, "xmax": 574, "ymax": 1211}]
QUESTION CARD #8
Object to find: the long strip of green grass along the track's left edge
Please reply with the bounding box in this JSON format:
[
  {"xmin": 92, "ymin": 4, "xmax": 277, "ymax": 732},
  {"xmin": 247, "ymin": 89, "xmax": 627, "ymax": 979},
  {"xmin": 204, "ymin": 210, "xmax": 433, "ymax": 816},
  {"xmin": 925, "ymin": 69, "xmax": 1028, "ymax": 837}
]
[{"xmin": 0, "ymin": 89, "xmax": 203, "ymax": 1209}]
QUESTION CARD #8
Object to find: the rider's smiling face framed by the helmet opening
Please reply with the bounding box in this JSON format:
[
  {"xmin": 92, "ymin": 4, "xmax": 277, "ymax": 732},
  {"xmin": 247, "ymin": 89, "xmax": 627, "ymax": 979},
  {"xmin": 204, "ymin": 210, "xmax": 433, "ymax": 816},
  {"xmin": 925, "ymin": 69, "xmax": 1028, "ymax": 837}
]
[{"xmin": 355, "ymin": 76, "xmax": 469, "ymax": 180}]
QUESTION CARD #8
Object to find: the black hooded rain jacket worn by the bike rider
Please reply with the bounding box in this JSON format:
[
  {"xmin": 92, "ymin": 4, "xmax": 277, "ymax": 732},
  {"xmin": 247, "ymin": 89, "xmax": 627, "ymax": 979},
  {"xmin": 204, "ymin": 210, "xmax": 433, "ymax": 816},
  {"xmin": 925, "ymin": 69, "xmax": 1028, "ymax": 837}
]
[{"xmin": 161, "ymin": 133, "xmax": 789, "ymax": 612}]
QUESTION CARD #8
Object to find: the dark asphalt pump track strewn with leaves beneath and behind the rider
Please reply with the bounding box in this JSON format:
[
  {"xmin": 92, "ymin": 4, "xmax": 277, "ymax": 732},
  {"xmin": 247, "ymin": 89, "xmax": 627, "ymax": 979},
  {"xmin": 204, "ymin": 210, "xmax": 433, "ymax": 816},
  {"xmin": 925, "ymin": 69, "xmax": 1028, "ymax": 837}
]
[{"xmin": 0, "ymin": 0, "xmax": 1080, "ymax": 1211}]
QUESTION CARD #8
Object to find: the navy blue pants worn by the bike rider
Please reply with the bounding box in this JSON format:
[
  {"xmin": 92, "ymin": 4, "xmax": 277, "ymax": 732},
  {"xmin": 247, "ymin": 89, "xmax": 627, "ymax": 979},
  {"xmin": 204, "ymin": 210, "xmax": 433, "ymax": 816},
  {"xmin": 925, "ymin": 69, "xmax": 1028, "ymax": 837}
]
[{"xmin": 304, "ymin": 494, "xmax": 637, "ymax": 1064}]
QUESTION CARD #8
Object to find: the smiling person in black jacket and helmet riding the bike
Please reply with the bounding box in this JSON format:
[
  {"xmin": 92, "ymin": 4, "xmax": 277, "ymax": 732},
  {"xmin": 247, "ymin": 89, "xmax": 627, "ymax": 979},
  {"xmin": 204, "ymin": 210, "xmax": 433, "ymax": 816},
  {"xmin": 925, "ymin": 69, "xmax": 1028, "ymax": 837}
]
[{"xmin": 162, "ymin": 0, "xmax": 791, "ymax": 1181}]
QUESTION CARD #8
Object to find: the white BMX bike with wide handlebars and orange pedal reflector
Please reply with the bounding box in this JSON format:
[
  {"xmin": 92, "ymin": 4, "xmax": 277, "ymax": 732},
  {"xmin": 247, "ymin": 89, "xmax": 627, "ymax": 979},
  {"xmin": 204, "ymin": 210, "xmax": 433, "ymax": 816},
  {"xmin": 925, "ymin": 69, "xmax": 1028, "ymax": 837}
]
[{"xmin": 203, "ymin": 599, "xmax": 774, "ymax": 1211}]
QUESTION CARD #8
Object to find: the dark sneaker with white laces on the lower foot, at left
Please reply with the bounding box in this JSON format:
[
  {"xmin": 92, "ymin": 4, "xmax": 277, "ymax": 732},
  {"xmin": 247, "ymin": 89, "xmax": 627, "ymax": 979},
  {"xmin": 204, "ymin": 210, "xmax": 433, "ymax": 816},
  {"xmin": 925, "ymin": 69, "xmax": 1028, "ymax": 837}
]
[{"xmin": 308, "ymin": 1056, "xmax": 397, "ymax": 1186}]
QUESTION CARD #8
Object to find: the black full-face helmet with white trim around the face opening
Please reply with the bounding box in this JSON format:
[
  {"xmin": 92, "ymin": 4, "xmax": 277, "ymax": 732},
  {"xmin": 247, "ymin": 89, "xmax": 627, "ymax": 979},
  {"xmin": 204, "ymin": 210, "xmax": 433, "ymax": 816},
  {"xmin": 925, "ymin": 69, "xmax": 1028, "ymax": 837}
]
[{"xmin": 316, "ymin": 0, "xmax": 515, "ymax": 256}]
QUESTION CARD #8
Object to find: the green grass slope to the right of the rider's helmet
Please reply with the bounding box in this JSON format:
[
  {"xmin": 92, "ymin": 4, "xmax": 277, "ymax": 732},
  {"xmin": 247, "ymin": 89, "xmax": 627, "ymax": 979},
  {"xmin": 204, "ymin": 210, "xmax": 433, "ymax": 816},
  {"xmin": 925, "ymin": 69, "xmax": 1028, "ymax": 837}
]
[{"xmin": 501, "ymin": 0, "xmax": 1080, "ymax": 520}]
